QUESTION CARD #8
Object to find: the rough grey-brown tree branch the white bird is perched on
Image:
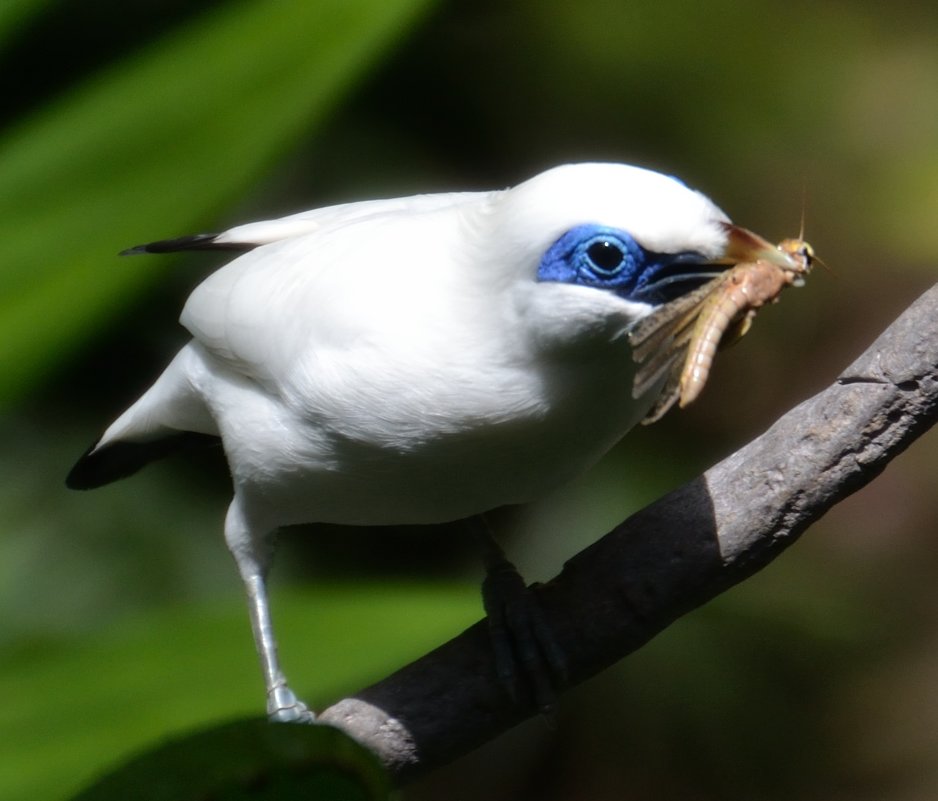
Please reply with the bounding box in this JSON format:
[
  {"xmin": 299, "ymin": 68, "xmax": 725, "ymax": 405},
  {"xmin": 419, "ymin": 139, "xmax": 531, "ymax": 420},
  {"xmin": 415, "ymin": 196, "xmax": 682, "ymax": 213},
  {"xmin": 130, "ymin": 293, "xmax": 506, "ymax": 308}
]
[{"xmin": 321, "ymin": 285, "xmax": 938, "ymax": 780}]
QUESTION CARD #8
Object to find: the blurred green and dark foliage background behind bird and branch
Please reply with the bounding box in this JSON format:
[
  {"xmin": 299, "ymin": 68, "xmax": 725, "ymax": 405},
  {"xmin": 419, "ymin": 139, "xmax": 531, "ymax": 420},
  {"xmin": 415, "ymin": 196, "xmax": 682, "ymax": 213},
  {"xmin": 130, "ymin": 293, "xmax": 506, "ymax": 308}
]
[{"xmin": 0, "ymin": 0, "xmax": 938, "ymax": 801}]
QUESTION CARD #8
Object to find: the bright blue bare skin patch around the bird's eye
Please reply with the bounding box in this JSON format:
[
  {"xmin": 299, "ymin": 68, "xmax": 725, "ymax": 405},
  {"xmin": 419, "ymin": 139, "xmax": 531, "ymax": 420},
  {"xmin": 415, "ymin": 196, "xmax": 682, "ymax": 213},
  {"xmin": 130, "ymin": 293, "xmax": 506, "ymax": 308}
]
[{"xmin": 537, "ymin": 225, "xmax": 716, "ymax": 304}]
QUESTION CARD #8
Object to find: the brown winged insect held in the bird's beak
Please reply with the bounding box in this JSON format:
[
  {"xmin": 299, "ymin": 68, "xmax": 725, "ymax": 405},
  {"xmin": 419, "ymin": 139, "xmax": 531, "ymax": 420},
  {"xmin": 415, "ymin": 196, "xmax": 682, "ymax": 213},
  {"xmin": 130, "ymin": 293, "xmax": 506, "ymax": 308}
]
[{"xmin": 629, "ymin": 225, "xmax": 816, "ymax": 425}]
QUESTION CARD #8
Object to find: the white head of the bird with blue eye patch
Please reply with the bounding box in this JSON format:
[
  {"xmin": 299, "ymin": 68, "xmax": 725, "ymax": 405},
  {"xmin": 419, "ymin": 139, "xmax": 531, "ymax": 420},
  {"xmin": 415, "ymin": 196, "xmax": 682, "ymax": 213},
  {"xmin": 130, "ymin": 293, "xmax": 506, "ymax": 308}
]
[{"xmin": 489, "ymin": 163, "xmax": 766, "ymax": 351}]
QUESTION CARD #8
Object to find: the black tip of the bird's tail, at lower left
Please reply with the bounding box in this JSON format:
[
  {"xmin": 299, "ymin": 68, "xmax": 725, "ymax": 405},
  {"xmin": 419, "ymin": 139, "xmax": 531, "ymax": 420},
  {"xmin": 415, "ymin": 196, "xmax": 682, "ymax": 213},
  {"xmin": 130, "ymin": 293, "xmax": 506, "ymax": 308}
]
[{"xmin": 65, "ymin": 431, "xmax": 221, "ymax": 490}]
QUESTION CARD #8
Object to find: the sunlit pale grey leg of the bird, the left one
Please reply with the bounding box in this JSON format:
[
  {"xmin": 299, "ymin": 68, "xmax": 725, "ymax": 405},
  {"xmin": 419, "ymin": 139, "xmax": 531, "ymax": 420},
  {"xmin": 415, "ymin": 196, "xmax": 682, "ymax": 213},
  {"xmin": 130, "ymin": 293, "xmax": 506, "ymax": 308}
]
[{"xmin": 225, "ymin": 497, "xmax": 316, "ymax": 723}]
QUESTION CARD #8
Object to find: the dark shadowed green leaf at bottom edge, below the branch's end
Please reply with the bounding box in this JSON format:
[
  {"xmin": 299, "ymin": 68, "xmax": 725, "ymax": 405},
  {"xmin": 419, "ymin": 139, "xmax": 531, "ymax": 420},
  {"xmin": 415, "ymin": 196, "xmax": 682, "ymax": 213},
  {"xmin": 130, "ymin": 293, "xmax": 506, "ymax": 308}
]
[{"xmin": 74, "ymin": 719, "xmax": 391, "ymax": 801}]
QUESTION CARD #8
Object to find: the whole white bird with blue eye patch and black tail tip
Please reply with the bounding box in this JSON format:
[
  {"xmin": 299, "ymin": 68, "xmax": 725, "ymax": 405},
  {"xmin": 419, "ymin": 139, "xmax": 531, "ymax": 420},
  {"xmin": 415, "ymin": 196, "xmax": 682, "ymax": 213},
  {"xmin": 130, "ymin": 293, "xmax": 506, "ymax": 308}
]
[{"xmin": 68, "ymin": 164, "xmax": 776, "ymax": 720}]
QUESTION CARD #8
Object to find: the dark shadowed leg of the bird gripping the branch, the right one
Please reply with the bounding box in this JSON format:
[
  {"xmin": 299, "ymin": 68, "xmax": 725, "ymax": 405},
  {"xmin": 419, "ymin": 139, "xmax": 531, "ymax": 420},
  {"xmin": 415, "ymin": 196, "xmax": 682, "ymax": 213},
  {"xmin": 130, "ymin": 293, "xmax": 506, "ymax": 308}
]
[{"xmin": 468, "ymin": 515, "xmax": 566, "ymax": 712}]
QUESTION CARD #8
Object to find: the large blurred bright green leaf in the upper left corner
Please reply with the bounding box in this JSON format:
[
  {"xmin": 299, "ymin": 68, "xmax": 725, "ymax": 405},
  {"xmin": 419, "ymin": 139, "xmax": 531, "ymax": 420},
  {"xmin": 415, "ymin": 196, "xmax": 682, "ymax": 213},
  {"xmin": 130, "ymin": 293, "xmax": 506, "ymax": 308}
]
[{"xmin": 0, "ymin": 0, "xmax": 428, "ymax": 408}]
